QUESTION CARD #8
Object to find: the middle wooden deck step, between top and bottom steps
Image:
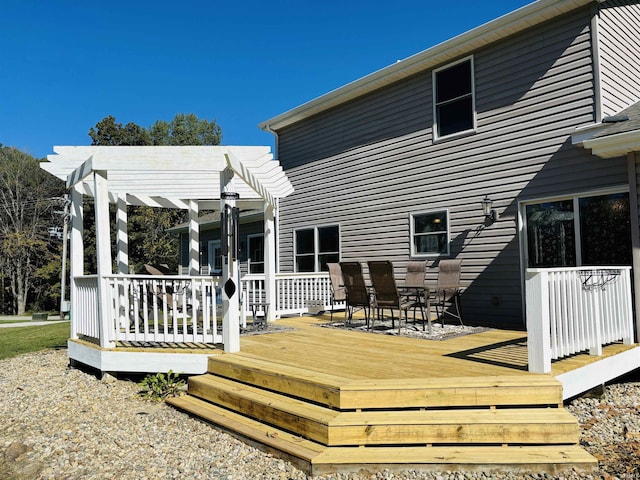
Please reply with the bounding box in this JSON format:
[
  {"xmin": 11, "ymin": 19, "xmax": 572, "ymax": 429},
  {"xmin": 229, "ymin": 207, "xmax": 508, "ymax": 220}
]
[{"xmin": 189, "ymin": 374, "xmax": 579, "ymax": 446}]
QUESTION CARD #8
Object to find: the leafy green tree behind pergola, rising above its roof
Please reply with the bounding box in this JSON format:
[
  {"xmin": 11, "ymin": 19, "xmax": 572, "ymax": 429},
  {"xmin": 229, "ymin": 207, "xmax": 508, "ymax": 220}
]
[{"xmin": 89, "ymin": 113, "xmax": 222, "ymax": 272}]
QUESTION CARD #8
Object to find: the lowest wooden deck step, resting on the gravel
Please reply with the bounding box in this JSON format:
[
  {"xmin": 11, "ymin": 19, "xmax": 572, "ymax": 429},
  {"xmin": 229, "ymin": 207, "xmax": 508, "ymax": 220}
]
[{"xmin": 167, "ymin": 396, "xmax": 597, "ymax": 475}]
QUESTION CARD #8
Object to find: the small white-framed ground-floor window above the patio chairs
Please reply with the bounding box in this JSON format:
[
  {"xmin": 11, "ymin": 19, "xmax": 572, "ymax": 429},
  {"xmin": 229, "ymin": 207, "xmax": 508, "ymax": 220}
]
[{"xmin": 410, "ymin": 210, "xmax": 449, "ymax": 257}]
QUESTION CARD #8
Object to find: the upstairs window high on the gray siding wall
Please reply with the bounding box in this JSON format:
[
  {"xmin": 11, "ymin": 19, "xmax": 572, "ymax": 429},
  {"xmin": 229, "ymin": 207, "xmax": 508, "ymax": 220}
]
[{"xmin": 433, "ymin": 58, "xmax": 475, "ymax": 138}]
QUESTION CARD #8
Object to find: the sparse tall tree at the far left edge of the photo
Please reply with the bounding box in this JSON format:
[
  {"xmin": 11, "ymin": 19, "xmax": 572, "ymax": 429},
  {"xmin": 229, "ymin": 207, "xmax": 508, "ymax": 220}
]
[{"xmin": 0, "ymin": 147, "xmax": 64, "ymax": 315}]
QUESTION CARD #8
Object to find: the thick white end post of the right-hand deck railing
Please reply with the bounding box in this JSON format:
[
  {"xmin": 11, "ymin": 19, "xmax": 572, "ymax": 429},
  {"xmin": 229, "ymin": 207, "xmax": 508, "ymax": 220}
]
[{"xmin": 526, "ymin": 270, "xmax": 551, "ymax": 373}]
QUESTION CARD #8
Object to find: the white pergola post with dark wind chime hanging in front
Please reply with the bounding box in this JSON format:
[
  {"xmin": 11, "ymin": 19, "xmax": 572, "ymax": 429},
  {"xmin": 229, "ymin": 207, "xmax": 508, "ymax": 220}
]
[{"xmin": 220, "ymin": 168, "xmax": 242, "ymax": 353}]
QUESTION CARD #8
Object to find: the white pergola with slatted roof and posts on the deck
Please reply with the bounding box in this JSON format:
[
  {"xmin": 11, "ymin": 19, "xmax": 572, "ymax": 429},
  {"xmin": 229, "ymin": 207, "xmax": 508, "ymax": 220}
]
[{"xmin": 40, "ymin": 146, "xmax": 293, "ymax": 351}]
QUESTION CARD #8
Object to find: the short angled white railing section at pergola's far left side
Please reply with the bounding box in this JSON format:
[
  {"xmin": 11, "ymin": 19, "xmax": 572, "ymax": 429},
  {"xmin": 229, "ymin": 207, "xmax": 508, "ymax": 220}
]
[{"xmin": 70, "ymin": 275, "xmax": 100, "ymax": 339}]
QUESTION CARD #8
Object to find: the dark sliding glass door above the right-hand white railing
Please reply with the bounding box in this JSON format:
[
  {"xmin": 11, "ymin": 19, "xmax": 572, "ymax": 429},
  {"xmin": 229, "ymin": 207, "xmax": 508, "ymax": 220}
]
[{"xmin": 525, "ymin": 193, "xmax": 631, "ymax": 268}]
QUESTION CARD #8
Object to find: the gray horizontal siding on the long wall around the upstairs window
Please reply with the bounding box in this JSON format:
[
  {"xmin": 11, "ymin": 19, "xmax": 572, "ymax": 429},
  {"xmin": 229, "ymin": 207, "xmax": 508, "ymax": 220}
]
[{"xmin": 278, "ymin": 8, "xmax": 627, "ymax": 324}]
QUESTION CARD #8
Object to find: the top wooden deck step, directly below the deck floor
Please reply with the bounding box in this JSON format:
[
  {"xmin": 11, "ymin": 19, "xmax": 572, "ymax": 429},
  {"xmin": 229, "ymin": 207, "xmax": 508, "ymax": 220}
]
[{"xmin": 208, "ymin": 354, "xmax": 562, "ymax": 410}]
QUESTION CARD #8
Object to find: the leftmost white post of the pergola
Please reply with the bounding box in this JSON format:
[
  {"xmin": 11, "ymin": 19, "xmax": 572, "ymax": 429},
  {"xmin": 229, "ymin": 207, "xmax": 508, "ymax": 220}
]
[{"xmin": 69, "ymin": 186, "xmax": 84, "ymax": 339}]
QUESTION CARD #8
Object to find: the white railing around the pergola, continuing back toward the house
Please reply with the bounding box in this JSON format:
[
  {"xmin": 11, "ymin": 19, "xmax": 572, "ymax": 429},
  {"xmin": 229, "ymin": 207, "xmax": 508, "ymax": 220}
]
[{"xmin": 71, "ymin": 273, "xmax": 344, "ymax": 343}]
